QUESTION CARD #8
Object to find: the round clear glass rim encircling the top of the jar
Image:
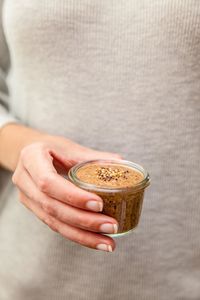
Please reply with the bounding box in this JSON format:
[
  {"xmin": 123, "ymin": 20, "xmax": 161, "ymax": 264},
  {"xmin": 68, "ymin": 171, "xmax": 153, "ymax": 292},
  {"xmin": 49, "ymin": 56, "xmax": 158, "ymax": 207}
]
[{"xmin": 68, "ymin": 159, "xmax": 150, "ymax": 192}]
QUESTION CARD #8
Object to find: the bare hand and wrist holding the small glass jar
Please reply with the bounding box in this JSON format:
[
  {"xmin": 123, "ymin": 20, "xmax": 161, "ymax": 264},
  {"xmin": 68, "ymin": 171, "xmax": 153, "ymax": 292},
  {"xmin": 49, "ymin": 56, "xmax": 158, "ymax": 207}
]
[{"xmin": 0, "ymin": 123, "xmax": 122, "ymax": 252}]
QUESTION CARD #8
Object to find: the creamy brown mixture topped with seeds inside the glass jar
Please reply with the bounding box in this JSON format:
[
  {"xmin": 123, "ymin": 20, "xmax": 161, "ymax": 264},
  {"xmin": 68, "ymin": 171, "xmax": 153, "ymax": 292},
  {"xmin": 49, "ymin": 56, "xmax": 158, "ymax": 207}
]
[{"xmin": 73, "ymin": 163, "xmax": 147, "ymax": 234}]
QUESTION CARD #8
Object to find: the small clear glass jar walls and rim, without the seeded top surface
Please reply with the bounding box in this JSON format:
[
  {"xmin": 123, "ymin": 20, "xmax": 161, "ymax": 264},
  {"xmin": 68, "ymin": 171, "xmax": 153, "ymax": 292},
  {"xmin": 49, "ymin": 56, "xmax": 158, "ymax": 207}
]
[{"xmin": 68, "ymin": 159, "xmax": 150, "ymax": 237}]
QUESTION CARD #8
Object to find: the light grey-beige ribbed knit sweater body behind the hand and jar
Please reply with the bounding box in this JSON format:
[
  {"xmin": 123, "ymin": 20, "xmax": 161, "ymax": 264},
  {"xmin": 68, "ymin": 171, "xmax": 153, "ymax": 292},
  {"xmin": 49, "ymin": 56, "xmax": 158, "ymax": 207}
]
[{"xmin": 0, "ymin": 0, "xmax": 200, "ymax": 300}]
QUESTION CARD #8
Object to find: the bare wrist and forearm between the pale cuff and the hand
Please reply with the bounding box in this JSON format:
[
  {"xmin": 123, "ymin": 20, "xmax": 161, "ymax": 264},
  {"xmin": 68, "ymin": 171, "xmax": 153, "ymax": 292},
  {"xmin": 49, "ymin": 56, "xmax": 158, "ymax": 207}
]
[{"xmin": 0, "ymin": 123, "xmax": 45, "ymax": 171}]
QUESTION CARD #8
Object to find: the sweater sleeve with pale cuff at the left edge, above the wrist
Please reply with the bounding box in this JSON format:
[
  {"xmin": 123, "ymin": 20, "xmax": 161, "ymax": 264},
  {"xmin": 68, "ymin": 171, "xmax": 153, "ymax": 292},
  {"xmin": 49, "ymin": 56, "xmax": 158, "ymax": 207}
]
[{"xmin": 0, "ymin": 0, "xmax": 19, "ymax": 129}]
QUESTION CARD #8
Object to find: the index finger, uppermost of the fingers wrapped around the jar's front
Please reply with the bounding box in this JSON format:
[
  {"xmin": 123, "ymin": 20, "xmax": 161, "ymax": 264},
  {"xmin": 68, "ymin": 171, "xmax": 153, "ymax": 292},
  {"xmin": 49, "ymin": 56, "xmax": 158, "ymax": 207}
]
[{"xmin": 21, "ymin": 145, "xmax": 103, "ymax": 212}]
